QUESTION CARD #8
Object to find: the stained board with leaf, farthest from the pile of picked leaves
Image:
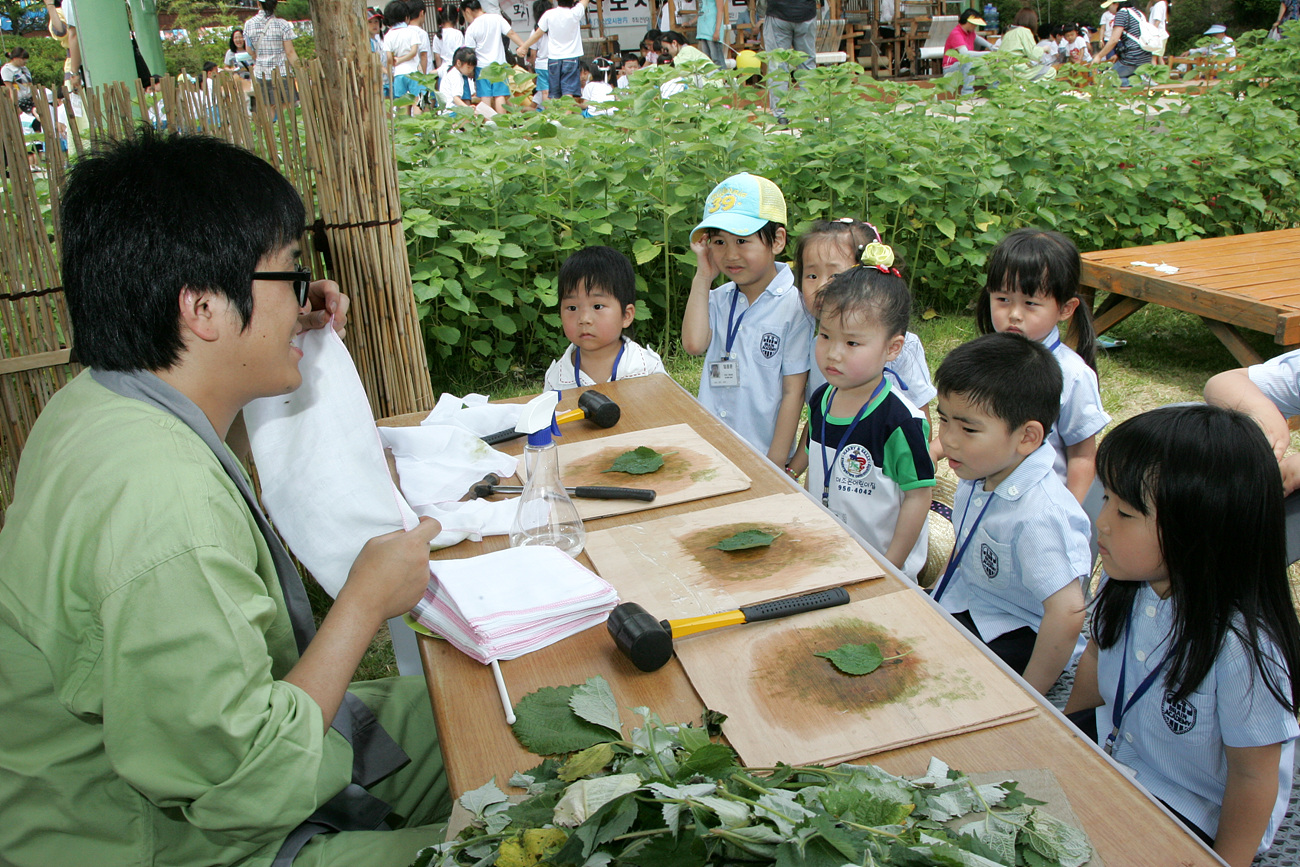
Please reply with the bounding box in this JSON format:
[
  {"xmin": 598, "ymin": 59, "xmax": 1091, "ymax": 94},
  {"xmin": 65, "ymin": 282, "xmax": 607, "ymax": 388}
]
[{"xmin": 519, "ymin": 425, "xmax": 751, "ymax": 520}]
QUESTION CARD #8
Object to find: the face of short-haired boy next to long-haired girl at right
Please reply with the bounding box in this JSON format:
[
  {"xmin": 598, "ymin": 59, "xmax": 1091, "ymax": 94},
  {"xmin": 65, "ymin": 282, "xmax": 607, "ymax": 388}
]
[{"xmin": 936, "ymin": 394, "xmax": 1043, "ymax": 490}]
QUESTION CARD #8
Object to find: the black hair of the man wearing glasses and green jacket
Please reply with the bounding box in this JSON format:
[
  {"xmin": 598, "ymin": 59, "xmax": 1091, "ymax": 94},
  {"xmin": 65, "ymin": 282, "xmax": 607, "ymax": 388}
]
[{"xmin": 61, "ymin": 125, "xmax": 306, "ymax": 370}]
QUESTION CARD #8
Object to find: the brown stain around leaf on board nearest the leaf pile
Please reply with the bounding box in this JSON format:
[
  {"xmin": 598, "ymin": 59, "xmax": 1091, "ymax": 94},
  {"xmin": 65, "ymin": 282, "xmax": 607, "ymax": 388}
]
[{"xmin": 750, "ymin": 617, "xmax": 930, "ymax": 729}]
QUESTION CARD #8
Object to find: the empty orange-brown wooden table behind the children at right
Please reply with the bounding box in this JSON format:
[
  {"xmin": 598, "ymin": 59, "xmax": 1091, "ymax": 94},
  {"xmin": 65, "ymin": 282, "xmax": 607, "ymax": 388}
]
[{"xmin": 1079, "ymin": 229, "xmax": 1300, "ymax": 365}]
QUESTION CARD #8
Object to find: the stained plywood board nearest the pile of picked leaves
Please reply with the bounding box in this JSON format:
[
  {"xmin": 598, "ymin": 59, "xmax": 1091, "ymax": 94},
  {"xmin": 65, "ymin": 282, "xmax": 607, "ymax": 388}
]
[{"xmin": 676, "ymin": 590, "xmax": 1037, "ymax": 767}]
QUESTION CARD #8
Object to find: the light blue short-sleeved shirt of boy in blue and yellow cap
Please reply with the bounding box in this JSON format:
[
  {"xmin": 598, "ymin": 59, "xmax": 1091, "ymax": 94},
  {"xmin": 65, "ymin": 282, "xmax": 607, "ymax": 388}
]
[{"xmin": 699, "ymin": 263, "xmax": 813, "ymax": 454}]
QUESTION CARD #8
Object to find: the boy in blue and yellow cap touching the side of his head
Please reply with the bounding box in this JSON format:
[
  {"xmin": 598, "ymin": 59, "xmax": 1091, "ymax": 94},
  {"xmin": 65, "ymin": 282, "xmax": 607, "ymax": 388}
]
[{"xmin": 681, "ymin": 172, "xmax": 813, "ymax": 467}]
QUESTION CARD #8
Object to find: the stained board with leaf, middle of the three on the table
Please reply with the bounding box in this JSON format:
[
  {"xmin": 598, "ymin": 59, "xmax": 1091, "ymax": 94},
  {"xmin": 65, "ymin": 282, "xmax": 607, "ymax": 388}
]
[{"xmin": 586, "ymin": 493, "xmax": 884, "ymax": 619}]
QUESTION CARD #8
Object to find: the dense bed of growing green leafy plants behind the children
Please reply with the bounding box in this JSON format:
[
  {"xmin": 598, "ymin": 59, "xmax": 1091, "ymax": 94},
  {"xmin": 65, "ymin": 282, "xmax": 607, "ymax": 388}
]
[{"xmin": 395, "ymin": 38, "xmax": 1300, "ymax": 376}]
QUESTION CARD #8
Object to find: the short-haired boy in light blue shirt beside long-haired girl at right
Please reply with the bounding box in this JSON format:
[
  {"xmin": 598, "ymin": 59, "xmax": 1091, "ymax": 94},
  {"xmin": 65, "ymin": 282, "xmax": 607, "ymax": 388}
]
[{"xmin": 933, "ymin": 333, "xmax": 1092, "ymax": 693}]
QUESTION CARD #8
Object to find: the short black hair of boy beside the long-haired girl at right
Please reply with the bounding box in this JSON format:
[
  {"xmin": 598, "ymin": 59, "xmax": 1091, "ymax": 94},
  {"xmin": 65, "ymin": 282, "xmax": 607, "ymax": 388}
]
[{"xmin": 935, "ymin": 331, "xmax": 1062, "ymax": 435}]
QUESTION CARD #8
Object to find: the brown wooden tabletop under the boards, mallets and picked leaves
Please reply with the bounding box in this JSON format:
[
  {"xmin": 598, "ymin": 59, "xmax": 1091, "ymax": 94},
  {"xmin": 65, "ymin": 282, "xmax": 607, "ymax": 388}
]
[{"xmin": 384, "ymin": 376, "xmax": 1219, "ymax": 866}]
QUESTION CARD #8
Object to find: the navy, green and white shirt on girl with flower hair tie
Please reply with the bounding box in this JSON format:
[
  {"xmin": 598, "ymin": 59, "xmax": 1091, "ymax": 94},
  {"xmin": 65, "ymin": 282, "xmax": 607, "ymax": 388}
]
[{"xmin": 807, "ymin": 380, "xmax": 935, "ymax": 581}]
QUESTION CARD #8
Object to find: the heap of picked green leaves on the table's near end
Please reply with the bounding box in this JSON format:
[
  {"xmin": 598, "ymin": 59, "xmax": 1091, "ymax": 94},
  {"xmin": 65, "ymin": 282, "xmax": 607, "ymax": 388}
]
[{"xmin": 412, "ymin": 677, "xmax": 1092, "ymax": 867}]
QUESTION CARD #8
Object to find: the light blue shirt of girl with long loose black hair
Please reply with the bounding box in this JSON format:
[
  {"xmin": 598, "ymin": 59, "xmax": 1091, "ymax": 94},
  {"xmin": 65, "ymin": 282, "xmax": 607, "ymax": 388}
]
[{"xmin": 1097, "ymin": 585, "xmax": 1300, "ymax": 848}]
